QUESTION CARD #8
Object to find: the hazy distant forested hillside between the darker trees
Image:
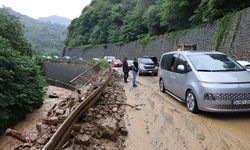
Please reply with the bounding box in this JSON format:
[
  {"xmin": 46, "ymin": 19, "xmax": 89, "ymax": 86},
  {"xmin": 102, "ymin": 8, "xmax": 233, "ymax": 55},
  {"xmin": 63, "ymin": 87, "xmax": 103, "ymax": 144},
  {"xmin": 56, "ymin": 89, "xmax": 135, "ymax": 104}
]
[{"xmin": 0, "ymin": 8, "xmax": 66, "ymax": 56}]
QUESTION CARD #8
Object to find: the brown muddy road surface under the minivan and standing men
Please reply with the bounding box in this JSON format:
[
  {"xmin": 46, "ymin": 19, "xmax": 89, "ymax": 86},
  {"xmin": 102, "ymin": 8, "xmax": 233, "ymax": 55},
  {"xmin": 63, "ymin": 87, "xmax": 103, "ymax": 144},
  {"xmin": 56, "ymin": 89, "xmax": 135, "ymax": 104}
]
[{"xmin": 124, "ymin": 70, "xmax": 250, "ymax": 150}]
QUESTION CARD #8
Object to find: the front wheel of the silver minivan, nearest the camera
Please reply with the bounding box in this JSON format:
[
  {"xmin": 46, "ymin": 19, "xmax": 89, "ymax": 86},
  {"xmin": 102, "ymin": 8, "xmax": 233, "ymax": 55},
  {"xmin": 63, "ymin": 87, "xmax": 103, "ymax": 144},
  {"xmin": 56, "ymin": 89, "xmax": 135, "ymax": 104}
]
[{"xmin": 186, "ymin": 90, "xmax": 199, "ymax": 114}]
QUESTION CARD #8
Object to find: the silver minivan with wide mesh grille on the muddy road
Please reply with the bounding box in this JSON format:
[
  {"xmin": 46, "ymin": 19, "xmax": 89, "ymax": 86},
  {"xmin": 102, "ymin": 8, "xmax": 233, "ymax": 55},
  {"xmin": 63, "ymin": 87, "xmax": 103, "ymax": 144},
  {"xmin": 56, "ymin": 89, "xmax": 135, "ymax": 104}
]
[{"xmin": 159, "ymin": 51, "xmax": 250, "ymax": 113}]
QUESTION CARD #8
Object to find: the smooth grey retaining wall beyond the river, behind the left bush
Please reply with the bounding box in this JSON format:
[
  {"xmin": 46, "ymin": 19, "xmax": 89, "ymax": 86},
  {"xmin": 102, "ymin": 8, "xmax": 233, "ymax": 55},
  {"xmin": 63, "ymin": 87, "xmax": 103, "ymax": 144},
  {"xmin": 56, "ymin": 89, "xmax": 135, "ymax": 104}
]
[{"xmin": 42, "ymin": 61, "xmax": 91, "ymax": 84}]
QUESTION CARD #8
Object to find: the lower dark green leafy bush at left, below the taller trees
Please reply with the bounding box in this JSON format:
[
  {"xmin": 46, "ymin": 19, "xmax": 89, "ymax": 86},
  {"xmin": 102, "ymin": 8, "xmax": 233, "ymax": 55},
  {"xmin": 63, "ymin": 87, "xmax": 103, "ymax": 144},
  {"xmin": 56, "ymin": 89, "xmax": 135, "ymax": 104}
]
[{"xmin": 0, "ymin": 37, "xmax": 45, "ymax": 132}]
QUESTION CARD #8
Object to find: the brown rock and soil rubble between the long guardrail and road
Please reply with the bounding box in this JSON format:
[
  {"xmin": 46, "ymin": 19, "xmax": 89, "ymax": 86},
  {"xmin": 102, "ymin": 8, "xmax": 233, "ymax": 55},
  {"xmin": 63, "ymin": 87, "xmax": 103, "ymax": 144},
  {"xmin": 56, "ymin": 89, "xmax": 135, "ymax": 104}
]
[{"xmin": 64, "ymin": 73, "xmax": 128, "ymax": 150}]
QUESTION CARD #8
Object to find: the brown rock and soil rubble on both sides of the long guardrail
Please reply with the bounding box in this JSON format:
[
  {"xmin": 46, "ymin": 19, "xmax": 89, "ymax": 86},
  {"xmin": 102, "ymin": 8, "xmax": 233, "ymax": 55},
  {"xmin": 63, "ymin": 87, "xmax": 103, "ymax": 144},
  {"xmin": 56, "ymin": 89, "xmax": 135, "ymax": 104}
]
[{"xmin": 9, "ymin": 72, "xmax": 128, "ymax": 150}]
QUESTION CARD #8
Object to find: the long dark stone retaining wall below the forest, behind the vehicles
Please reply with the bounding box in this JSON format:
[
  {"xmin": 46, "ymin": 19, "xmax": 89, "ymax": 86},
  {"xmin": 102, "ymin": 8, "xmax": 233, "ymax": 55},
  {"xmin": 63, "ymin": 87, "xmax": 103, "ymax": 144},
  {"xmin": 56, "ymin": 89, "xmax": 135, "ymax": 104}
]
[{"xmin": 65, "ymin": 8, "xmax": 250, "ymax": 60}]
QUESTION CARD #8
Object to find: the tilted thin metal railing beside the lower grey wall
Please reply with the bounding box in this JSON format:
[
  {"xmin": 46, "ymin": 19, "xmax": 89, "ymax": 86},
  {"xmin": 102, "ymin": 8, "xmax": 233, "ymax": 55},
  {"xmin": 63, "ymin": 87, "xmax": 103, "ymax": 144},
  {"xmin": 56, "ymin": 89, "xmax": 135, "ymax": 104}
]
[{"xmin": 69, "ymin": 65, "xmax": 101, "ymax": 86}]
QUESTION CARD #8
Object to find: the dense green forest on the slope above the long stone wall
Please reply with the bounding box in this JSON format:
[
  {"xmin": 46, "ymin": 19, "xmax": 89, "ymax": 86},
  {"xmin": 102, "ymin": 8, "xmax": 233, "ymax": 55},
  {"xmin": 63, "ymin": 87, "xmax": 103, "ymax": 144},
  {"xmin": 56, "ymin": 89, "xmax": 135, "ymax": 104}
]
[{"xmin": 66, "ymin": 0, "xmax": 250, "ymax": 48}]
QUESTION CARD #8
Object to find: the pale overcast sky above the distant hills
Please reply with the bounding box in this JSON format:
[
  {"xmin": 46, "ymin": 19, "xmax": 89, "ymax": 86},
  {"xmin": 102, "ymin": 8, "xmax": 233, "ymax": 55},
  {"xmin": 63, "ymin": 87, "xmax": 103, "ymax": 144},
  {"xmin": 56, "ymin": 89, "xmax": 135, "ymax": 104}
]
[{"xmin": 0, "ymin": 0, "xmax": 91, "ymax": 19}]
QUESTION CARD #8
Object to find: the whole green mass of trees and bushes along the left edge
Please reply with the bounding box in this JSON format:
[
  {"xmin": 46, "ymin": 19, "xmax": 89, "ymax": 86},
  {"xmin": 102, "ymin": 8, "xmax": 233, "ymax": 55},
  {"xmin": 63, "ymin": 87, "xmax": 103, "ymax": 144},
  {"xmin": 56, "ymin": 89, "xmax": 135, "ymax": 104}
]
[{"xmin": 0, "ymin": 10, "xmax": 45, "ymax": 133}]
